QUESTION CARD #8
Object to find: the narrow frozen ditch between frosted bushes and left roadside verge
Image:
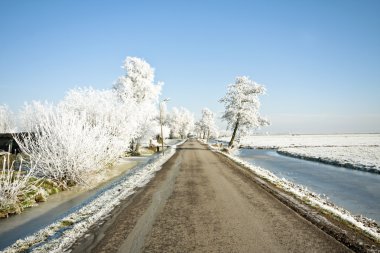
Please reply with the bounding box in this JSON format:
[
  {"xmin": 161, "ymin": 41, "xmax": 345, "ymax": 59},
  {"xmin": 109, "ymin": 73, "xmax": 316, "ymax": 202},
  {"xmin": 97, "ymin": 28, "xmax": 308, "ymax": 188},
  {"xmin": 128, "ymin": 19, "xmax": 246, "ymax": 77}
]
[{"xmin": 0, "ymin": 156, "xmax": 150, "ymax": 250}]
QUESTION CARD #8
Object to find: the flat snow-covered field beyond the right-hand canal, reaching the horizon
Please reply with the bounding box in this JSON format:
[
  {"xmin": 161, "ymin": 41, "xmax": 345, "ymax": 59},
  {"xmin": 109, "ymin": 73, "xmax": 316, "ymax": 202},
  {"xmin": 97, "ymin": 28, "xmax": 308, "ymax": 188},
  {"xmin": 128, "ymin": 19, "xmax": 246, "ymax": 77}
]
[{"xmin": 220, "ymin": 134, "xmax": 380, "ymax": 173}]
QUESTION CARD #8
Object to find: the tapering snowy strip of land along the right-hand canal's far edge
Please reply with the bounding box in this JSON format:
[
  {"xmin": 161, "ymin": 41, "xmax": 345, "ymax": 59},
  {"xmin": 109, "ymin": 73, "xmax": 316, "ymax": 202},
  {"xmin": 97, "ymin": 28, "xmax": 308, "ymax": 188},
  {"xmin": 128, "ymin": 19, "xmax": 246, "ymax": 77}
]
[{"xmin": 277, "ymin": 146, "xmax": 380, "ymax": 174}]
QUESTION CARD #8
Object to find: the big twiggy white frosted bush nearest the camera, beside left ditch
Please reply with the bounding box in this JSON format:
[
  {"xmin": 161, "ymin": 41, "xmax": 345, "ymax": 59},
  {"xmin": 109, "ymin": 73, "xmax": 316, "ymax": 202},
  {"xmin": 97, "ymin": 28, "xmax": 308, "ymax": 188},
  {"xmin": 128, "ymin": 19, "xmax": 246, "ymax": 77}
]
[{"xmin": 16, "ymin": 99, "xmax": 121, "ymax": 187}]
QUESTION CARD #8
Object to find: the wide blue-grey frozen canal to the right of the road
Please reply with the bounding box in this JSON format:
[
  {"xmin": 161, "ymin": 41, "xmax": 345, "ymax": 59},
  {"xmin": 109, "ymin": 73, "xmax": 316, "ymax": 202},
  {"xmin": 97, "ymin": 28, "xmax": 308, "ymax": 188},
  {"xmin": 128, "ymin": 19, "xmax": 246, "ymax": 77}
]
[{"xmin": 235, "ymin": 149, "xmax": 380, "ymax": 222}]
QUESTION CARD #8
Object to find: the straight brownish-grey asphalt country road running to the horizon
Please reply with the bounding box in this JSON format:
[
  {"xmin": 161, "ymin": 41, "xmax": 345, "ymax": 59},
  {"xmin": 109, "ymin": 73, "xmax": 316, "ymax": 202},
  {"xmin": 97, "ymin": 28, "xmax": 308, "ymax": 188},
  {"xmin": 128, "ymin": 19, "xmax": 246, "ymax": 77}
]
[{"xmin": 72, "ymin": 140, "xmax": 350, "ymax": 252}]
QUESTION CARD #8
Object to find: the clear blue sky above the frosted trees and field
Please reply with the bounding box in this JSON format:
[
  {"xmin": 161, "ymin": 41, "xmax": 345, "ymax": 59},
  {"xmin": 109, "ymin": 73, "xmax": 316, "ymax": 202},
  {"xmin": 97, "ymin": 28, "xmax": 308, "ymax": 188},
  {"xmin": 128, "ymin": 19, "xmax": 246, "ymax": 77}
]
[{"xmin": 0, "ymin": 0, "xmax": 380, "ymax": 133}]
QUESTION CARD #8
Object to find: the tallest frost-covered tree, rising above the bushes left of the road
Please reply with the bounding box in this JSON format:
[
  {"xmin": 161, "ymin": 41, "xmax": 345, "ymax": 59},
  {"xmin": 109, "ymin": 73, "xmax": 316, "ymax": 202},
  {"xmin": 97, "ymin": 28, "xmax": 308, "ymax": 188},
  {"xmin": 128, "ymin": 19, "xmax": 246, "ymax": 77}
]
[{"xmin": 114, "ymin": 57, "xmax": 163, "ymax": 151}]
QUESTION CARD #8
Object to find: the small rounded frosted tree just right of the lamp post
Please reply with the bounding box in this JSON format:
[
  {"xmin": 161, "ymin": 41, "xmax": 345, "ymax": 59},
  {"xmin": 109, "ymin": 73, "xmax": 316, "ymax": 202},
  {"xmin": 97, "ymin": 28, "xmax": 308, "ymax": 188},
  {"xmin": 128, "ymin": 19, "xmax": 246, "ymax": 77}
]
[{"xmin": 169, "ymin": 107, "xmax": 194, "ymax": 139}]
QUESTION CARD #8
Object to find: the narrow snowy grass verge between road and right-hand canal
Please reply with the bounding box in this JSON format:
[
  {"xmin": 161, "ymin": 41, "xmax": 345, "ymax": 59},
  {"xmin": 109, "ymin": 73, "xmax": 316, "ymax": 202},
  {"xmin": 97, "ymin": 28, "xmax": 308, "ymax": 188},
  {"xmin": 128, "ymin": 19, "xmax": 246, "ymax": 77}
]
[{"xmin": 203, "ymin": 142, "xmax": 380, "ymax": 241}]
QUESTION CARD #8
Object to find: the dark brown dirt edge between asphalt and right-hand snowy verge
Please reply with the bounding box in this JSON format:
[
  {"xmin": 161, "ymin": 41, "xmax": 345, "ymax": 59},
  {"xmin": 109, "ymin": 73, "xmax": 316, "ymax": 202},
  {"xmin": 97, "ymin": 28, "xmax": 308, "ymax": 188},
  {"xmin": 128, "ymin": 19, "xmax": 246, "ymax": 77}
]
[{"xmin": 208, "ymin": 144, "xmax": 380, "ymax": 252}]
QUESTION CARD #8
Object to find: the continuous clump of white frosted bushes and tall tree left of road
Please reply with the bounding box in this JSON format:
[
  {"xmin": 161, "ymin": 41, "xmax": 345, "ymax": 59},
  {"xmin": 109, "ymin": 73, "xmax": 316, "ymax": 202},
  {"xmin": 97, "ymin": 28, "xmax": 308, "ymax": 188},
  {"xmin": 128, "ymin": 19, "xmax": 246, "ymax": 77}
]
[{"xmin": 17, "ymin": 57, "xmax": 161, "ymax": 187}]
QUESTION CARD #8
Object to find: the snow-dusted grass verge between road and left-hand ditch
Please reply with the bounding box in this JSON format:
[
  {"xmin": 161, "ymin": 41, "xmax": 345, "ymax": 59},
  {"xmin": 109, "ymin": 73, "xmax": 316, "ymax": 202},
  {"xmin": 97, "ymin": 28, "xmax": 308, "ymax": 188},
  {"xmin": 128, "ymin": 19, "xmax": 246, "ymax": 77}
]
[{"xmin": 2, "ymin": 141, "xmax": 184, "ymax": 253}]
